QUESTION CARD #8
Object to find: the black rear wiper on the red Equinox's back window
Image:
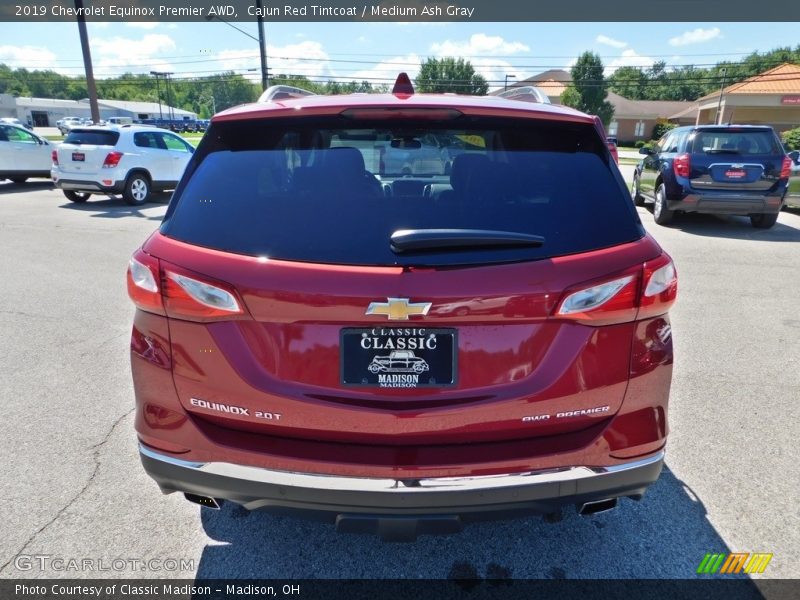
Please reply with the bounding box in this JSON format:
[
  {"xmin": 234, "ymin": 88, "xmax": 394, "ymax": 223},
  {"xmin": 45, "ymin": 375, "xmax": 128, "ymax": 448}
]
[{"xmin": 391, "ymin": 229, "xmax": 544, "ymax": 254}]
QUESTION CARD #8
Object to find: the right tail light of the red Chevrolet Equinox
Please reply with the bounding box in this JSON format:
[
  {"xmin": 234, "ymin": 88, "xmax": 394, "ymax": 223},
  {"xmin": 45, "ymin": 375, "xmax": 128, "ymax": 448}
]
[{"xmin": 556, "ymin": 254, "xmax": 678, "ymax": 325}]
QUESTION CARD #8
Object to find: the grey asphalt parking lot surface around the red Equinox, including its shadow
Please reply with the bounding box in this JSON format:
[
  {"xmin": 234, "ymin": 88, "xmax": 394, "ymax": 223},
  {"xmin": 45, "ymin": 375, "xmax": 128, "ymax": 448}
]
[{"xmin": 0, "ymin": 180, "xmax": 800, "ymax": 578}]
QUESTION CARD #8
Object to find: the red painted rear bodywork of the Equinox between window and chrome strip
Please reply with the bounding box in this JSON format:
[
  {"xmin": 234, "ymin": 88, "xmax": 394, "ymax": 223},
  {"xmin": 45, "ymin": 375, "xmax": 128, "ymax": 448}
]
[{"xmin": 133, "ymin": 233, "xmax": 672, "ymax": 476}]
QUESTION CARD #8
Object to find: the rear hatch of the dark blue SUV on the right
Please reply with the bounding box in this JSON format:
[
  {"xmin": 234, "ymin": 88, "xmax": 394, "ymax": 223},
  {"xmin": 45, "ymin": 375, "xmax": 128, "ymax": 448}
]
[{"xmin": 689, "ymin": 127, "xmax": 784, "ymax": 192}]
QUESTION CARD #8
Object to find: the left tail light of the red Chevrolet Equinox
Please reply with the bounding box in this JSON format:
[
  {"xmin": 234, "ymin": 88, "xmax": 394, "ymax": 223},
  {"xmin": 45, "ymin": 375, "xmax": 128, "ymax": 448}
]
[{"xmin": 128, "ymin": 250, "xmax": 245, "ymax": 321}]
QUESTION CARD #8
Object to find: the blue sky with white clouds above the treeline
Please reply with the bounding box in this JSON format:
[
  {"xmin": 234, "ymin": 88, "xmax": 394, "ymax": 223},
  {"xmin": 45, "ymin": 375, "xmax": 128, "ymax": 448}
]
[{"xmin": 0, "ymin": 21, "xmax": 800, "ymax": 87}]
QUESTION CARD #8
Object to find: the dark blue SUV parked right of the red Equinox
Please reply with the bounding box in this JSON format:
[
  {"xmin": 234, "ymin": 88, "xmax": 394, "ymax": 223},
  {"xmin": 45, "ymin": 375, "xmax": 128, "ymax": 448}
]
[{"xmin": 631, "ymin": 125, "xmax": 791, "ymax": 229}]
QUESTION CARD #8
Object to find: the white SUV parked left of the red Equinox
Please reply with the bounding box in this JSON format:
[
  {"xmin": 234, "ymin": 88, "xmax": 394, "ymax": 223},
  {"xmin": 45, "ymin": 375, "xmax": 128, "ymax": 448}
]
[{"xmin": 50, "ymin": 125, "xmax": 194, "ymax": 205}]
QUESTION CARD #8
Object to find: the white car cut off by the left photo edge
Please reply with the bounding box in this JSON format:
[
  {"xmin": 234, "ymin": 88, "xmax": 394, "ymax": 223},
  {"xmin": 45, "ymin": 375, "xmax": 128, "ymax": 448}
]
[{"xmin": 0, "ymin": 122, "xmax": 53, "ymax": 183}]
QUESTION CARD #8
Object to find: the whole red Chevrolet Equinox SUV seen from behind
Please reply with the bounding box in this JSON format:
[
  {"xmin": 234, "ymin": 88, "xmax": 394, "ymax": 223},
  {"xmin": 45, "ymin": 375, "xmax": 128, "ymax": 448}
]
[{"xmin": 128, "ymin": 76, "xmax": 677, "ymax": 539}]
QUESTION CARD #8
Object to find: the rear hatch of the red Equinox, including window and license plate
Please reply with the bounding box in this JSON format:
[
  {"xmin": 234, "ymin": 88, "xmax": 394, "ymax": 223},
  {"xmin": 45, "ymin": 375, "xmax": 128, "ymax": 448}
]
[{"xmin": 150, "ymin": 112, "xmax": 660, "ymax": 444}]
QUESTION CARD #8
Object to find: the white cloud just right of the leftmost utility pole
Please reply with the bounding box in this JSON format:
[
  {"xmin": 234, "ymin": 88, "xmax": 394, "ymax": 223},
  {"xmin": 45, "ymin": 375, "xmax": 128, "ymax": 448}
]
[{"xmin": 91, "ymin": 33, "xmax": 176, "ymax": 76}]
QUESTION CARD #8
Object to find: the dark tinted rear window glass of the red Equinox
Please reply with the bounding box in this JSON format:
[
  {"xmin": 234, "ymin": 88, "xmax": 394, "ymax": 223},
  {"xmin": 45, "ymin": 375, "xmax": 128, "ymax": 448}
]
[{"xmin": 161, "ymin": 117, "xmax": 643, "ymax": 266}]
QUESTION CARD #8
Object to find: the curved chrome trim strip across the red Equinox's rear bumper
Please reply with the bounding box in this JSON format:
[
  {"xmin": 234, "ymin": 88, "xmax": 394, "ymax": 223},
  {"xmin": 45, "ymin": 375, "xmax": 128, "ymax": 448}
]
[{"xmin": 139, "ymin": 444, "xmax": 666, "ymax": 493}]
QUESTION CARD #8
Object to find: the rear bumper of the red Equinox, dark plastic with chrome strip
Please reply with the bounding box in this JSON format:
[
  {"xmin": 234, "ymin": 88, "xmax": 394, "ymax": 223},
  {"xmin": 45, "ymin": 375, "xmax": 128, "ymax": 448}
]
[{"xmin": 139, "ymin": 445, "xmax": 664, "ymax": 521}]
